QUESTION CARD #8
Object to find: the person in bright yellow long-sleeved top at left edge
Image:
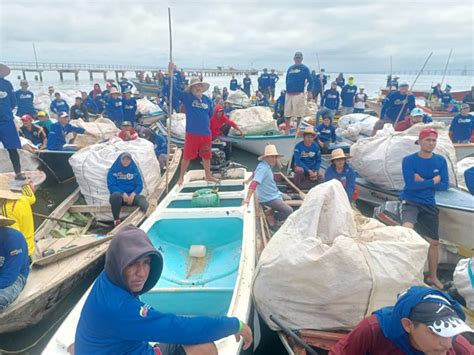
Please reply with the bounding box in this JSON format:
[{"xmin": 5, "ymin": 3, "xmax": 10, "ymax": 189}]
[{"xmin": 0, "ymin": 175, "xmax": 36, "ymax": 257}]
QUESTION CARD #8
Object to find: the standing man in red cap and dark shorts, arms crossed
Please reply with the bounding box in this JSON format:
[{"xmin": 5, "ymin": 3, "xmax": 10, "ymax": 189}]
[{"xmin": 400, "ymin": 128, "xmax": 449, "ymax": 289}]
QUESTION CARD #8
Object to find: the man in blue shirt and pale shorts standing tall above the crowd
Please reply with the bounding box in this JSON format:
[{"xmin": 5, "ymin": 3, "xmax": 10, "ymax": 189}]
[{"xmin": 285, "ymin": 52, "xmax": 311, "ymax": 135}]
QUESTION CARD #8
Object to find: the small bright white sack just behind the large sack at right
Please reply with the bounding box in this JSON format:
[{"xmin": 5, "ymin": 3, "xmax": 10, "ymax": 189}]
[{"xmin": 336, "ymin": 113, "xmax": 378, "ymax": 142}]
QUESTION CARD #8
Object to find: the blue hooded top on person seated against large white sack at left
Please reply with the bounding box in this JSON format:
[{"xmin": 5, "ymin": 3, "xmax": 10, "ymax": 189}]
[{"xmin": 107, "ymin": 153, "xmax": 143, "ymax": 195}]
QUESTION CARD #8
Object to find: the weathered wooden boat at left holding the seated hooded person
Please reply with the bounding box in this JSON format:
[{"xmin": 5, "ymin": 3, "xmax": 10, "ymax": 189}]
[{"xmin": 0, "ymin": 150, "xmax": 181, "ymax": 334}]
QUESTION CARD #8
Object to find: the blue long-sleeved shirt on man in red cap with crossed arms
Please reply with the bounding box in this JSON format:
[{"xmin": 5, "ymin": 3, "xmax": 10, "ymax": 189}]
[{"xmin": 400, "ymin": 153, "xmax": 449, "ymax": 205}]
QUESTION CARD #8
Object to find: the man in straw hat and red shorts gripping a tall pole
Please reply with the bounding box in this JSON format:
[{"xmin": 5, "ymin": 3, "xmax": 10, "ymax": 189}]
[{"xmin": 168, "ymin": 63, "xmax": 218, "ymax": 185}]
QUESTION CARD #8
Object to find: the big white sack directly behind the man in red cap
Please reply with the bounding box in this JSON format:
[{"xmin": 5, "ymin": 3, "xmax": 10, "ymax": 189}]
[{"xmin": 351, "ymin": 122, "xmax": 456, "ymax": 190}]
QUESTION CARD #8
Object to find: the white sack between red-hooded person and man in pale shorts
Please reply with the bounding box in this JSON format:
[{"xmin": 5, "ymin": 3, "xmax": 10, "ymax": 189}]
[{"xmin": 230, "ymin": 107, "xmax": 278, "ymax": 135}]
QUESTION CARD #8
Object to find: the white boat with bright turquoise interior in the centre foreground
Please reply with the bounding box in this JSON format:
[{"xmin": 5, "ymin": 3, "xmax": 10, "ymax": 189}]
[{"xmin": 43, "ymin": 168, "xmax": 256, "ymax": 355}]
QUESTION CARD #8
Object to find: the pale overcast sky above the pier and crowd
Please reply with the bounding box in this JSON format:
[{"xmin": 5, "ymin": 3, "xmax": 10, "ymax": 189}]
[{"xmin": 0, "ymin": 0, "xmax": 474, "ymax": 72}]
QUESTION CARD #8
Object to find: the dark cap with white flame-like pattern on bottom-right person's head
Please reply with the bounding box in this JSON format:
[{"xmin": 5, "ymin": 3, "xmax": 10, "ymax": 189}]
[{"xmin": 408, "ymin": 302, "xmax": 474, "ymax": 338}]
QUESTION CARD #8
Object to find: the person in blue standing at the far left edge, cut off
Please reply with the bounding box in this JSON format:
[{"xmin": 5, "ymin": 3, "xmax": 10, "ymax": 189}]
[{"xmin": 0, "ymin": 64, "xmax": 26, "ymax": 180}]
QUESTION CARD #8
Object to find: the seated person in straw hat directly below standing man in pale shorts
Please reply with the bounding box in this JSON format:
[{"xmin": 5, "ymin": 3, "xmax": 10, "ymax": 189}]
[{"xmin": 293, "ymin": 127, "xmax": 323, "ymax": 189}]
